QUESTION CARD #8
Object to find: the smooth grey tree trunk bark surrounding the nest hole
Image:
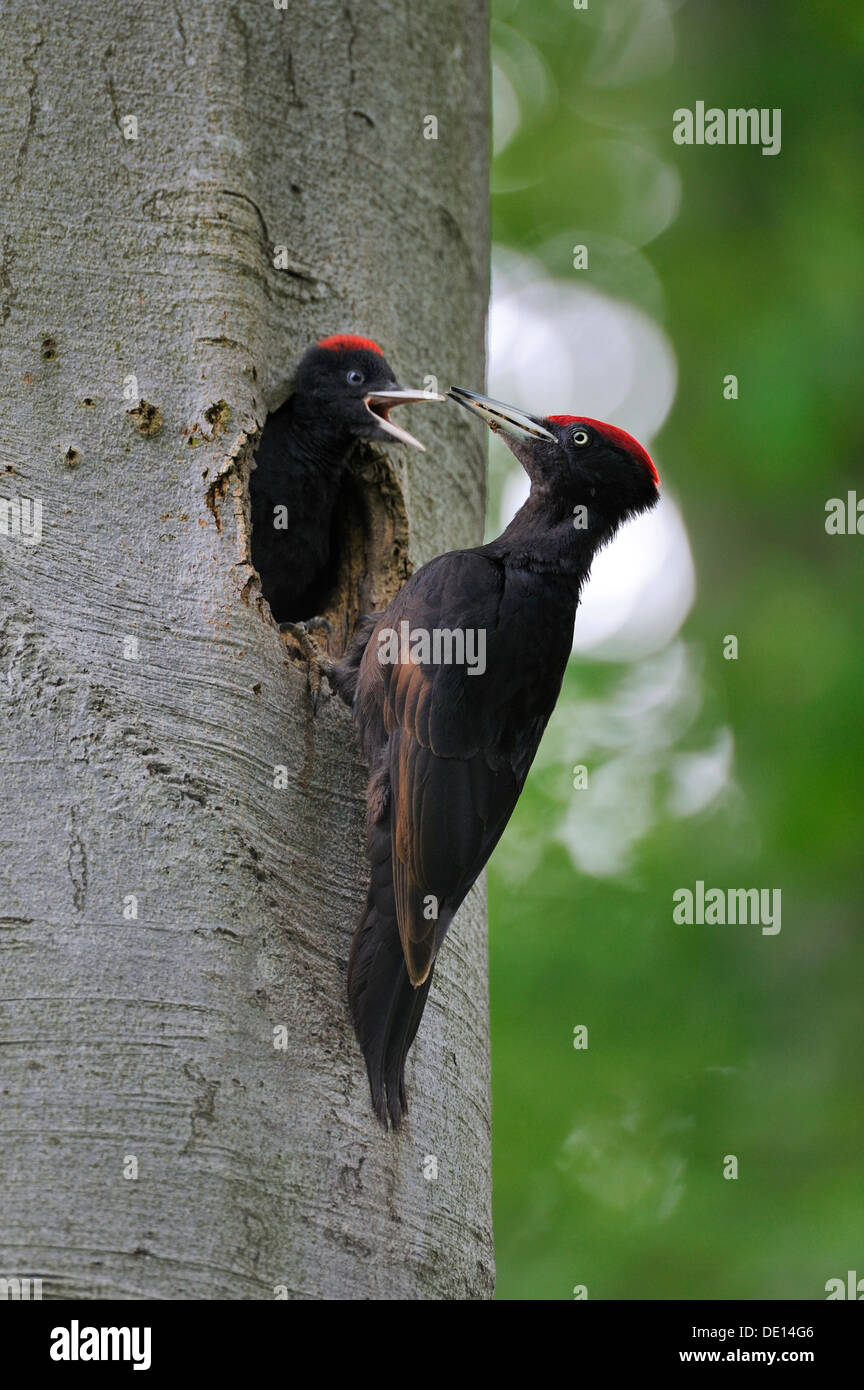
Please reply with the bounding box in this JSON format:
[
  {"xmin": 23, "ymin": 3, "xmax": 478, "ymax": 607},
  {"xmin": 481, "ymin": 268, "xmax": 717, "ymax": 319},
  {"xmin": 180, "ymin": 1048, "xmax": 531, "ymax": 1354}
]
[{"xmin": 0, "ymin": 0, "xmax": 492, "ymax": 1298}]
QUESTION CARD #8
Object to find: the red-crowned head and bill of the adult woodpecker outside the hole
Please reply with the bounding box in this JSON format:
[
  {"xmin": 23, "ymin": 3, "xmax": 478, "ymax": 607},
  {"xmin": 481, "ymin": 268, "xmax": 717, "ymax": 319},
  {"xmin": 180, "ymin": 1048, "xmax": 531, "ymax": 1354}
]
[{"xmin": 449, "ymin": 386, "xmax": 660, "ymax": 521}]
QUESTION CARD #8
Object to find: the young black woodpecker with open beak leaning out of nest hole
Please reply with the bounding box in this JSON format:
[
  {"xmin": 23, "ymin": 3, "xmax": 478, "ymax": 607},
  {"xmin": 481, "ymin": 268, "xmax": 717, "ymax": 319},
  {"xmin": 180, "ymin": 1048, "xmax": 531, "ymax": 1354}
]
[{"xmin": 250, "ymin": 334, "xmax": 443, "ymax": 621}]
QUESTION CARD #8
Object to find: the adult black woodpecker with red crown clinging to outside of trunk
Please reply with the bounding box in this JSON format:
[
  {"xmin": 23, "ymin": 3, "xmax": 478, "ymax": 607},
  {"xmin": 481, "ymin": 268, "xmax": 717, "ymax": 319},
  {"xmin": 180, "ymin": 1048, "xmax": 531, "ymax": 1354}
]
[{"xmin": 328, "ymin": 388, "xmax": 658, "ymax": 1127}]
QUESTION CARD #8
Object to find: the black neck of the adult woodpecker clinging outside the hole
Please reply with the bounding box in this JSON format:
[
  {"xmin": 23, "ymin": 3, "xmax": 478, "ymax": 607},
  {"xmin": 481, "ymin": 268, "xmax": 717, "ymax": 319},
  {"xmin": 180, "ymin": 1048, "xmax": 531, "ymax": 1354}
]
[{"xmin": 489, "ymin": 484, "xmax": 615, "ymax": 584}]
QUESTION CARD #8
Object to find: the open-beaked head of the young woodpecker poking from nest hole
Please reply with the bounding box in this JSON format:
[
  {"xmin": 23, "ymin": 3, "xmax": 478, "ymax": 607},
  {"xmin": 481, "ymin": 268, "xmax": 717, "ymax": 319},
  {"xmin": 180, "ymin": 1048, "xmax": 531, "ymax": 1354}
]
[{"xmin": 294, "ymin": 334, "xmax": 445, "ymax": 449}]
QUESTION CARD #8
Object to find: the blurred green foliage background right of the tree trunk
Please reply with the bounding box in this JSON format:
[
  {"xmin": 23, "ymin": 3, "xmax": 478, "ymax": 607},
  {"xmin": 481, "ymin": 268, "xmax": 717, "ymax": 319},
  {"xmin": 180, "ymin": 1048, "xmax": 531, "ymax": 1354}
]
[{"xmin": 489, "ymin": 0, "xmax": 864, "ymax": 1300}]
